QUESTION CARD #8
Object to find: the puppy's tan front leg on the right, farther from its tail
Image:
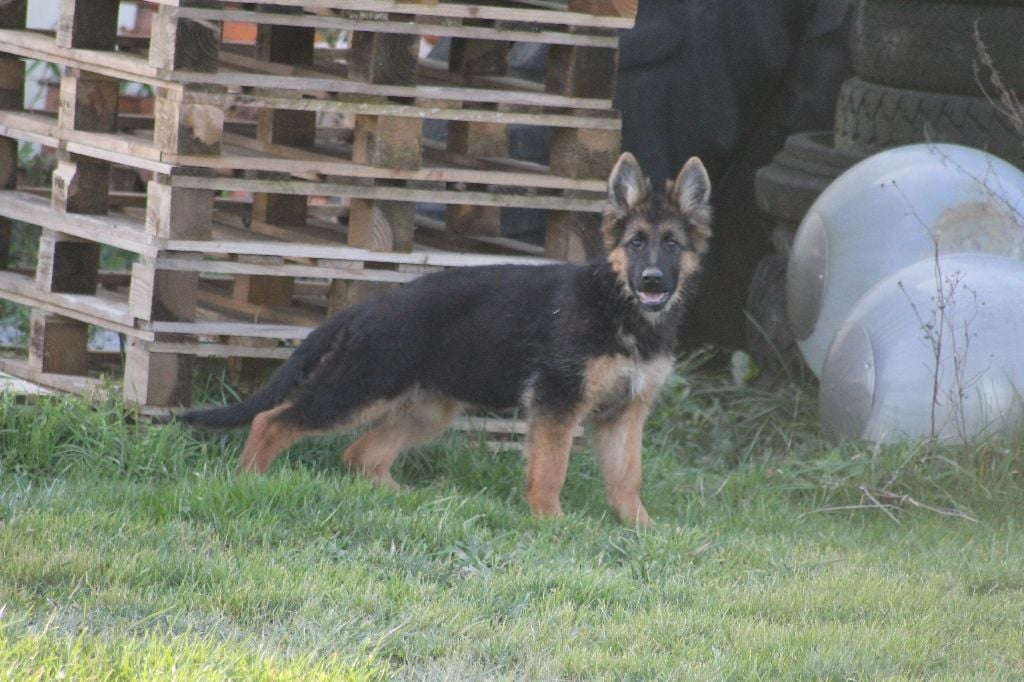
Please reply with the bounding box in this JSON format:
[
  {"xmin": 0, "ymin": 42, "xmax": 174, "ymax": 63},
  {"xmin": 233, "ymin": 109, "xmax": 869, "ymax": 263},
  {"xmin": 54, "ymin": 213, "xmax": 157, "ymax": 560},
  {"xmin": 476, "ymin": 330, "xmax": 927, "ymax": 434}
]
[{"xmin": 596, "ymin": 399, "xmax": 650, "ymax": 526}]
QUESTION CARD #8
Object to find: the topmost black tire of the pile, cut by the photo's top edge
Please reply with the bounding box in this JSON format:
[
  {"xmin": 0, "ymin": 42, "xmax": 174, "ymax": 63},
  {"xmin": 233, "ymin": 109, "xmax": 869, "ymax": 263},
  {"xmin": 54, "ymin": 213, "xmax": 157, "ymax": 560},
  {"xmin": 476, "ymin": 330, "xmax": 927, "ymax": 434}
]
[{"xmin": 851, "ymin": 0, "xmax": 1024, "ymax": 97}]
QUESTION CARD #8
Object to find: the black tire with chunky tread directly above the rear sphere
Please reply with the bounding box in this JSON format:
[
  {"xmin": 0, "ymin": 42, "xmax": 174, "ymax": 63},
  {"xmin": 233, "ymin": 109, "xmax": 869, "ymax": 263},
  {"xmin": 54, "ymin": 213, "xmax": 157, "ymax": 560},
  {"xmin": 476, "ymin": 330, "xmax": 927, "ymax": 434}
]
[{"xmin": 836, "ymin": 78, "xmax": 1024, "ymax": 166}]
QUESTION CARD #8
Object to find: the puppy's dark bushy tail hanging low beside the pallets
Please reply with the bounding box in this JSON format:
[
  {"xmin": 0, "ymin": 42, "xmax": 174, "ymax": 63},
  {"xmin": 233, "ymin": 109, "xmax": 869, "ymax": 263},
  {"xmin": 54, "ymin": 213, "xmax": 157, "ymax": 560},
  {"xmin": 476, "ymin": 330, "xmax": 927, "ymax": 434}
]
[{"xmin": 182, "ymin": 311, "xmax": 342, "ymax": 430}]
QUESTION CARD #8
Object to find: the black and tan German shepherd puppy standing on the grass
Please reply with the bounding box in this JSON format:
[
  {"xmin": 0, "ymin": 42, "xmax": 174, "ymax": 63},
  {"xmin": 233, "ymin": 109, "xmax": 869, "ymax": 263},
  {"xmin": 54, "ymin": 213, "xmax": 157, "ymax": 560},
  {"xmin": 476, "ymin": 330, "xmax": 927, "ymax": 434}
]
[{"xmin": 179, "ymin": 154, "xmax": 711, "ymax": 524}]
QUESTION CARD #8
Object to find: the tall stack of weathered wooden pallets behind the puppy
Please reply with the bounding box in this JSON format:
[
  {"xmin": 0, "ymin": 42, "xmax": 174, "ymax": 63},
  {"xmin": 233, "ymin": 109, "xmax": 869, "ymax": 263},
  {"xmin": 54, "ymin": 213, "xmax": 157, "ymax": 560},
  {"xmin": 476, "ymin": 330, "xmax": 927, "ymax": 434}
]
[{"xmin": 0, "ymin": 0, "xmax": 636, "ymax": 415}]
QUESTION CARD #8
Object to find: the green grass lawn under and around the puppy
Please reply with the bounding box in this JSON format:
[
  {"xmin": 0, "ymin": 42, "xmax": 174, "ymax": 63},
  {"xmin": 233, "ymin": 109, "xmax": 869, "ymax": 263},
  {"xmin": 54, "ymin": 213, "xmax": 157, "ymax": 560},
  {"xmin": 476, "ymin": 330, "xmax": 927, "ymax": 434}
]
[{"xmin": 0, "ymin": 368, "xmax": 1024, "ymax": 680}]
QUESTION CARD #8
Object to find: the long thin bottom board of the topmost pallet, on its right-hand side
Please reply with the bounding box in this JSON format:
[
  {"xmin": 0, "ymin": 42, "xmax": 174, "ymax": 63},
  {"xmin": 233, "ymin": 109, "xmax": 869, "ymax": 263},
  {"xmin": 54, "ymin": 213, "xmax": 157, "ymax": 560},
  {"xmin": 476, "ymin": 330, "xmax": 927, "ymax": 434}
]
[{"xmin": 179, "ymin": 7, "xmax": 618, "ymax": 48}]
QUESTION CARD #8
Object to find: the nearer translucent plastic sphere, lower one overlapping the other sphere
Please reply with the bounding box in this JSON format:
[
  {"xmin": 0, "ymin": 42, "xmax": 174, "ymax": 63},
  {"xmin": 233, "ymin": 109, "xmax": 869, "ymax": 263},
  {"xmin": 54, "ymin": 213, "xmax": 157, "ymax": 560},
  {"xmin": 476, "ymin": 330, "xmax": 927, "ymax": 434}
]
[{"xmin": 818, "ymin": 254, "xmax": 1024, "ymax": 443}]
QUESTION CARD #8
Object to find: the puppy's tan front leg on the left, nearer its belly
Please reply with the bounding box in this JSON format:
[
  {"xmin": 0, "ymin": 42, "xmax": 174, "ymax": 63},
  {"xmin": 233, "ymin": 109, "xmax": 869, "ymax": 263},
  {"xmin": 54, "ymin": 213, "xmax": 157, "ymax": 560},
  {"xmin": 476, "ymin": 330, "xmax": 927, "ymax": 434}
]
[{"xmin": 526, "ymin": 416, "xmax": 581, "ymax": 516}]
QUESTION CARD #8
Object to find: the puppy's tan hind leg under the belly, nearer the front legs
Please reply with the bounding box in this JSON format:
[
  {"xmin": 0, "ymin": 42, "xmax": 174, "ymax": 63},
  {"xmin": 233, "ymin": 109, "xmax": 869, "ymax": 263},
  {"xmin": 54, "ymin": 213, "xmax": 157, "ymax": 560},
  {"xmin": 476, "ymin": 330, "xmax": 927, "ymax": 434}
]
[{"xmin": 344, "ymin": 397, "xmax": 459, "ymax": 488}]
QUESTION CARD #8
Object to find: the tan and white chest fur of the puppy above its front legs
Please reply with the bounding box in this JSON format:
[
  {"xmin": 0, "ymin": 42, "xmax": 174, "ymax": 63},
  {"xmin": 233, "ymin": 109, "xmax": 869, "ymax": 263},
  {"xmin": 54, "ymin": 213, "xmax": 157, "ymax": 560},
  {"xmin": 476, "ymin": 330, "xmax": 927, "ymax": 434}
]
[{"xmin": 584, "ymin": 342, "xmax": 673, "ymax": 419}]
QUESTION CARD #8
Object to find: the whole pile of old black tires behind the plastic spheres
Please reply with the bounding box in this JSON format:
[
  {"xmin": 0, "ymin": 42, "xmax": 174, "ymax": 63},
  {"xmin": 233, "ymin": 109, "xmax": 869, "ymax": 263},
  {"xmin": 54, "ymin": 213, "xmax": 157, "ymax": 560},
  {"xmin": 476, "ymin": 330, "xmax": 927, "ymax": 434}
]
[{"xmin": 748, "ymin": 0, "xmax": 1024, "ymax": 379}]
